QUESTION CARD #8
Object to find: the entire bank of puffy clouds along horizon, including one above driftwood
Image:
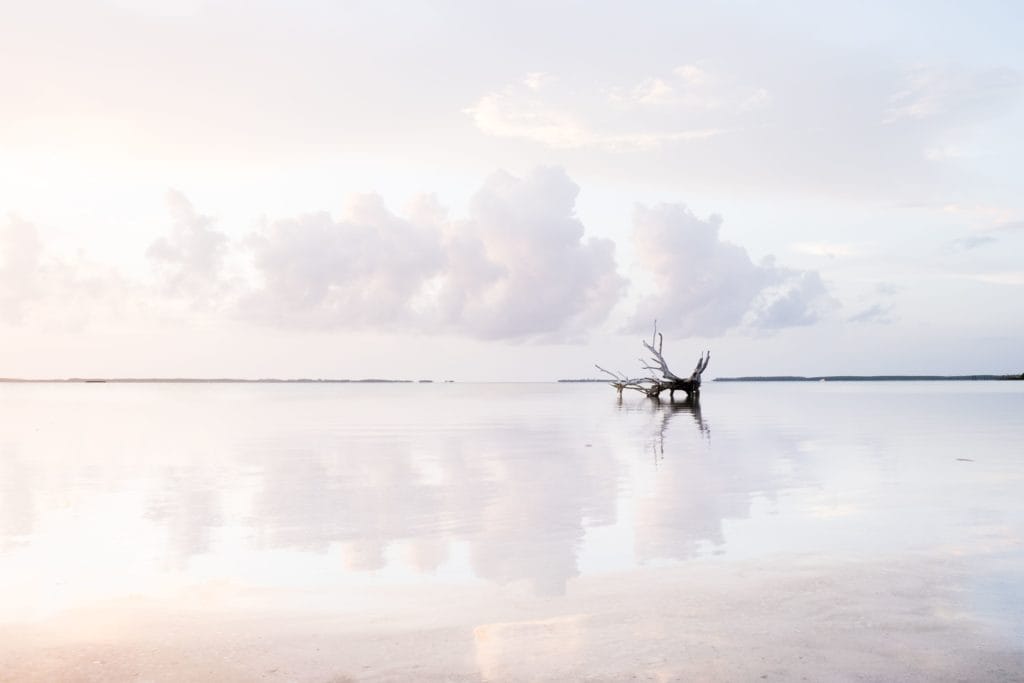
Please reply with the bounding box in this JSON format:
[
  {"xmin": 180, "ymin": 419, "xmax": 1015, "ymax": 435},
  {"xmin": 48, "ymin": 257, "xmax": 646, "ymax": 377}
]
[{"xmin": 0, "ymin": 168, "xmax": 831, "ymax": 342}]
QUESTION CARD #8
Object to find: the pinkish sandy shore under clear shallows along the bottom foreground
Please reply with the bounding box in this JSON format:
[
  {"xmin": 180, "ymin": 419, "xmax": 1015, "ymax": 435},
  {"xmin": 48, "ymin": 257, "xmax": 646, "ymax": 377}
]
[{"xmin": 0, "ymin": 560, "xmax": 1024, "ymax": 682}]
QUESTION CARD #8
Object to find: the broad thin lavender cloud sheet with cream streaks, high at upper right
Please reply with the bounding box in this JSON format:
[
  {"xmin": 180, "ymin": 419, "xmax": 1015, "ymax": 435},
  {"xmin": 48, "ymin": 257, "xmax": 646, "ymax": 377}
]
[{"xmin": 464, "ymin": 54, "xmax": 1024, "ymax": 205}]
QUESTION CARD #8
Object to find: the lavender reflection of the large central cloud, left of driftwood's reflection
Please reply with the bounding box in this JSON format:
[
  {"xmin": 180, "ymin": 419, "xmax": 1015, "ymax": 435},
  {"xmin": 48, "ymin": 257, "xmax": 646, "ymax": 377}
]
[{"xmin": 247, "ymin": 425, "xmax": 617, "ymax": 594}]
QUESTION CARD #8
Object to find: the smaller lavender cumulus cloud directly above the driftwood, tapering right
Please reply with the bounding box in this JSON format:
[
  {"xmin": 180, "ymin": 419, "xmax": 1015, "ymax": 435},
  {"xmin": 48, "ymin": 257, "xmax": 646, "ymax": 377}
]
[{"xmin": 632, "ymin": 204, "xmax": 833, "ymax": 337}]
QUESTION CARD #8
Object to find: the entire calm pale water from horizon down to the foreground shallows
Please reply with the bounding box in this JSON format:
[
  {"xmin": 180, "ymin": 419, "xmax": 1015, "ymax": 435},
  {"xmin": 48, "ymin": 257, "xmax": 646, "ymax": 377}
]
[{"xmin": 0, "ymin": 382, "xmax": 1024, "ymax": 680}]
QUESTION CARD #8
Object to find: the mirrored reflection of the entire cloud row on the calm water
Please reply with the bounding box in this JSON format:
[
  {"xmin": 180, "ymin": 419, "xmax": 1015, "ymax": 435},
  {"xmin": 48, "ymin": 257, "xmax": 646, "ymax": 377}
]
[{"xmin": 0, "ymin": 387, "xmax": 823, "ymax": 595}]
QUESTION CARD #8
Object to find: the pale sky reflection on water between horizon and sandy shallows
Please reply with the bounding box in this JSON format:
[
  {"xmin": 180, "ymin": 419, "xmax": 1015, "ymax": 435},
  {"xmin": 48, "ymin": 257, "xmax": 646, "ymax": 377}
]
[{"xmin": 0, "ymin": 383, "xmax": 1024, "ymax": 628}]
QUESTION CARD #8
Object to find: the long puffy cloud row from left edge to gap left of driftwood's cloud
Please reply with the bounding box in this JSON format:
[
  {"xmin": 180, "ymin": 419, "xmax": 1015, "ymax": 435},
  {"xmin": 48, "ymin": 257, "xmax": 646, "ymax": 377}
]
[{"xmin": 0, "ymin": 168, "xmax": 627, "ymax": 342}]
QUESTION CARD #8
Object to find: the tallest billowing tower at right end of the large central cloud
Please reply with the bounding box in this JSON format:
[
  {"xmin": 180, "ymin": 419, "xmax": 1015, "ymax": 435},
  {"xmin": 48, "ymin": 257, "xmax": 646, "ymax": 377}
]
[{"xmin": 439, "ymin": 169, "xmax": 626, "ymax": 338}]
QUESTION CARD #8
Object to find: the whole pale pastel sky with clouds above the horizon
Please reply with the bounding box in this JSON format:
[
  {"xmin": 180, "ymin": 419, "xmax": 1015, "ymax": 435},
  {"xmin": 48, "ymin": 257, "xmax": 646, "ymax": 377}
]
[{"xmin": 0, "ymin": 0, "xmax": 1024, "ymax": 381}]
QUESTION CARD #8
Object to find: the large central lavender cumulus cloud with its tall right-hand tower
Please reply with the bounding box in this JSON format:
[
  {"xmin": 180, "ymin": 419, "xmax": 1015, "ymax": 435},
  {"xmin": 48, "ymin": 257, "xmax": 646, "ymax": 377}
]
[{"xmin": 243, "ymin": 169, "xmax": 625, "ymax": 339}]
